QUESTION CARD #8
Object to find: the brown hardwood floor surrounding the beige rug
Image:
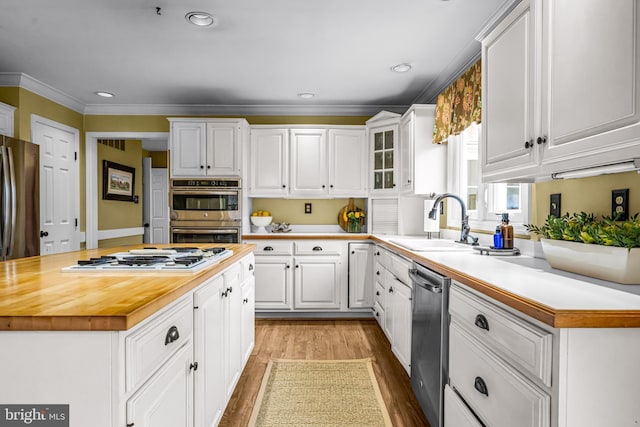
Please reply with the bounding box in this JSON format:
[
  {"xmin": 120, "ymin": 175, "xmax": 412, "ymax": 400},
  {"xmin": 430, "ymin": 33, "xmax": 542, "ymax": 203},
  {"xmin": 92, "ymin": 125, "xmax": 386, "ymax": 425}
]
[{"xmin": 220, "ymin": 319, "xmax": 429, "ymax": 427}]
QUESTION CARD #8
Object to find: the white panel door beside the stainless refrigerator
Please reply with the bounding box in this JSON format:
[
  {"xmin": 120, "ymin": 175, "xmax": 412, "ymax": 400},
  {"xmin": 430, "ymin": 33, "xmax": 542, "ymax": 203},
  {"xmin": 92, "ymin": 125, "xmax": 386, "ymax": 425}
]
[{"xmin": 32, "ymin": 118, "xmax": 80, "ymax": 255}]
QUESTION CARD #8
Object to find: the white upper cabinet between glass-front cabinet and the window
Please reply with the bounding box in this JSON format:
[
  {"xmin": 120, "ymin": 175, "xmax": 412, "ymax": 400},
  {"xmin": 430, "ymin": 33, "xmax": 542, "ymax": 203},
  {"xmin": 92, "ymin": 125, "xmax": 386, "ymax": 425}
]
[{"xmin": 399, "ymin": 104, "xmax": 447, "ymax": 195}]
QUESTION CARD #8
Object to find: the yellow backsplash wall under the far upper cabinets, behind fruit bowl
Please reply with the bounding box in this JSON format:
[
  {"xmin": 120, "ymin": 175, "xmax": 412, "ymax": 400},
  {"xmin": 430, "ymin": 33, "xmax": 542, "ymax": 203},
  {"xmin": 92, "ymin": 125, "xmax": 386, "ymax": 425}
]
[{"xmin": 252, "ymin": 198, "xmax": 365, "ymax": 225}]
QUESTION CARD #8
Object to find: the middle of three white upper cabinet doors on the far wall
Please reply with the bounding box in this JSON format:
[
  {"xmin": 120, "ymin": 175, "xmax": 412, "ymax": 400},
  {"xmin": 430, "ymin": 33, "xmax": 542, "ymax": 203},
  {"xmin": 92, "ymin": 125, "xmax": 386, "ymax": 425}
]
[{"xmin": 289, "ymin": 129, "xmax": 329, "ymax": 198}]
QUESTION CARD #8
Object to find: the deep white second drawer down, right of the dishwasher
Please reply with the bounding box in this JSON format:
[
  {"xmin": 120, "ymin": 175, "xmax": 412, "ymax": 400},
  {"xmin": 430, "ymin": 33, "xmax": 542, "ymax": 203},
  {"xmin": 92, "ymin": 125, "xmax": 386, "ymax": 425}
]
[{"xmin": 449, "ymin": 321, "xmax": 551, "ymax": 427}]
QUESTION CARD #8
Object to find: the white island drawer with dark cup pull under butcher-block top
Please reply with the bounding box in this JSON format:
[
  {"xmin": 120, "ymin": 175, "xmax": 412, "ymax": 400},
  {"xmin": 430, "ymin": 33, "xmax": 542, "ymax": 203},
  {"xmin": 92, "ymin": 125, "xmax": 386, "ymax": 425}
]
[{"xmin": 124, "ymin": 296, "xmax": 193, "ymax": 391}]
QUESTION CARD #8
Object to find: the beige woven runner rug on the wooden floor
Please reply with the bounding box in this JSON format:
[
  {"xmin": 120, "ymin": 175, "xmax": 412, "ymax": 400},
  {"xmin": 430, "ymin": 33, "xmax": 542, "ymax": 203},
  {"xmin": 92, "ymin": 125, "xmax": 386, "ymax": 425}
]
[{"xmin": 249, "ymin": 359, "xmax": 392, "ymax": 427}]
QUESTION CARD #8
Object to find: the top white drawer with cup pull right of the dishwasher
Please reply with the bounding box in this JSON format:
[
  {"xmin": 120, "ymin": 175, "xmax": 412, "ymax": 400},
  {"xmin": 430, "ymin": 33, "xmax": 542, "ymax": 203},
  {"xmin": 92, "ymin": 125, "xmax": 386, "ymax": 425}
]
[{"xmin": 449, "ymin": 285, "xmax": 553, "ymax": 386}]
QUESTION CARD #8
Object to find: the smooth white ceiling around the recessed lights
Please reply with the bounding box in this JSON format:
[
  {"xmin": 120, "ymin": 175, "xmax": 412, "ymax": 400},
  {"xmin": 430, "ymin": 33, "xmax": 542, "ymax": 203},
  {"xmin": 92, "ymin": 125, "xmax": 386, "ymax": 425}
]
[{"xmin": 0, "ymin": 0, "xmax": 514, "ymax": 115}]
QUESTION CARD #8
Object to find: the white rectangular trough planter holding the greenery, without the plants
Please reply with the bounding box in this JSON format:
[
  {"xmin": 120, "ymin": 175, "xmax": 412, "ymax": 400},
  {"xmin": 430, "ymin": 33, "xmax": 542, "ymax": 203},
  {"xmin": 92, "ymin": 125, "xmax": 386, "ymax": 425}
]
[{"xmin": 540, "ymin": 239, "xmax": 640, "ymax": 285}]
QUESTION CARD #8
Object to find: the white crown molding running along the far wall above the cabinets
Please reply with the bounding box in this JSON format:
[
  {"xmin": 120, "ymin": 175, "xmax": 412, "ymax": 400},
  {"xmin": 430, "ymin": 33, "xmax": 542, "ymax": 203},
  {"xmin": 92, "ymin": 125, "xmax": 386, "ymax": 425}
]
[{"xmin": 84, "ymin": 104, "xmax": 409, "ymax": 116}]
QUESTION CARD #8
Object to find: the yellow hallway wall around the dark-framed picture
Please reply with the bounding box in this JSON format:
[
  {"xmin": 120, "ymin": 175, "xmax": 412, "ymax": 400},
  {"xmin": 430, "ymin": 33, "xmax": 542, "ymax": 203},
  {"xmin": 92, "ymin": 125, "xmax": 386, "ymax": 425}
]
[{"xmin": 97, "ymin": 141, "xmax": 142, "ymax": 234}]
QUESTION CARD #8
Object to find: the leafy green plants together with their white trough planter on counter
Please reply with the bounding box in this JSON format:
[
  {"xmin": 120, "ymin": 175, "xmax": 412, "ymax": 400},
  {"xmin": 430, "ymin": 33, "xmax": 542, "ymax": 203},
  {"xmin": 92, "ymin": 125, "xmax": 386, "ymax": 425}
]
[{"xmin": 525, "ymin": 212, "xmax": 640, "ymax": 284}]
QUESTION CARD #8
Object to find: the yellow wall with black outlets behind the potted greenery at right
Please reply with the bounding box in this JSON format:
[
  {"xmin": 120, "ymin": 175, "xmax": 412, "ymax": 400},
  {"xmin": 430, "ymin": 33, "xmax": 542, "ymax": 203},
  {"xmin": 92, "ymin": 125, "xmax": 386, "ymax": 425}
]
[{"xmin": 530, "ymin": 172, "xmax": 640, "ymax": 234}]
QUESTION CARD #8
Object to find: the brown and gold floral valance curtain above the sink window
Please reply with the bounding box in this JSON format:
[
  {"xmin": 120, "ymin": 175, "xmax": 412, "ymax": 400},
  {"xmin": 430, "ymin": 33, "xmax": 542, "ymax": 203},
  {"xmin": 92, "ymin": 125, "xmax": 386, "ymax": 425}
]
[{"xmin": 433, "ymin": 60, "xmax": 482, "ymax": 144}]
